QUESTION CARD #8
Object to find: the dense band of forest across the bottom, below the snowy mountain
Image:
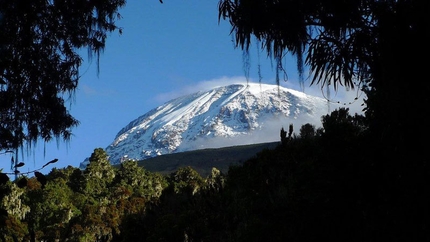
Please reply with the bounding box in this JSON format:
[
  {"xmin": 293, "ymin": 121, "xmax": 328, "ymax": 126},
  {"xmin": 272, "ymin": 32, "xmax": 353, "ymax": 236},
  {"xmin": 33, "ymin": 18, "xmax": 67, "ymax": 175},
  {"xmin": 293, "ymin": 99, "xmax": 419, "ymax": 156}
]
[{"xmin": 0, "ymin": 109, "xmax": 430, "ymax": 241}]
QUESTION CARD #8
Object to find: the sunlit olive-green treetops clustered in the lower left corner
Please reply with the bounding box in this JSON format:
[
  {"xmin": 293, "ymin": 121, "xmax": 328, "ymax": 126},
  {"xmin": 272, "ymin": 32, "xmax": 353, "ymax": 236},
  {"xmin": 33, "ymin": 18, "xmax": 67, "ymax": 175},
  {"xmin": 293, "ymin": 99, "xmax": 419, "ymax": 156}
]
[{"xmin": 0, "ymin": 148, "xmax": 168, "ymax": 241}]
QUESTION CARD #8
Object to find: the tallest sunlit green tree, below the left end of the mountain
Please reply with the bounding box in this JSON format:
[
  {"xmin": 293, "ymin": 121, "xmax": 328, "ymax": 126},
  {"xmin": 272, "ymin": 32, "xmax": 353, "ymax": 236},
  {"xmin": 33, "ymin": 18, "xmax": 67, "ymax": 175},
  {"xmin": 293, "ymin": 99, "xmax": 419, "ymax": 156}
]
[{"xmin": 69, "ymin": 148, "xmax": 120, "ymax": 241}]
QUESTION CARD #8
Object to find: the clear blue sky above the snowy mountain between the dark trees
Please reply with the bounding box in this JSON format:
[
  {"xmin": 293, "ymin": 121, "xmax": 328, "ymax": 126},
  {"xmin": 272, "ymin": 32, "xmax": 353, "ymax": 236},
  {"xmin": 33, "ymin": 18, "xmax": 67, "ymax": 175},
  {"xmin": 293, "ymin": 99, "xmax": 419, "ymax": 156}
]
[{"xmin": 0, "ymin": 0, "xmax": 366, "ymax": 177}]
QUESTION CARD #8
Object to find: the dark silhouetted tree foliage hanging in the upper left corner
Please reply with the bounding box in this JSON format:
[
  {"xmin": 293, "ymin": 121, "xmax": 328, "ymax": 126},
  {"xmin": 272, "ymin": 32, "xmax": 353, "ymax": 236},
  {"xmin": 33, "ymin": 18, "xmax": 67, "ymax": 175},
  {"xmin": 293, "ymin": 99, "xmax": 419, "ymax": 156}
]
[{"xmin": 0, "ymin": 0, "xmax": 125, "ymax": 153}]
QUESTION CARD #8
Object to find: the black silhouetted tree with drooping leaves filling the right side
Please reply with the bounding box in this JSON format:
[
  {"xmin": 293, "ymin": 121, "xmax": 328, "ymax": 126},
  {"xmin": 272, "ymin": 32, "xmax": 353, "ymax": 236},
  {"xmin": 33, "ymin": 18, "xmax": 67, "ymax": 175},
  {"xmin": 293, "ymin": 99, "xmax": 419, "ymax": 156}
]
[{"xmin": 219, "ymin": 0, "xmax": 430, "ymax": 240}]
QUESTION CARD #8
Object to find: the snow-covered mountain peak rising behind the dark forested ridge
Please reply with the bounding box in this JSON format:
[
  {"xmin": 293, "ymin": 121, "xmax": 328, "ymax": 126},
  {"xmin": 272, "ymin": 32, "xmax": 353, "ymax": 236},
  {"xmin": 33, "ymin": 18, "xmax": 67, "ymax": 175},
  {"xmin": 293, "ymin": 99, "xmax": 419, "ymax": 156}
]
[{"xmin": 81, "ymin": 83, "xmax": 336, "ymax": 167}]
